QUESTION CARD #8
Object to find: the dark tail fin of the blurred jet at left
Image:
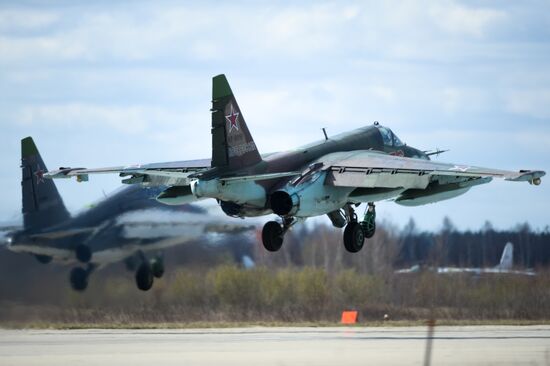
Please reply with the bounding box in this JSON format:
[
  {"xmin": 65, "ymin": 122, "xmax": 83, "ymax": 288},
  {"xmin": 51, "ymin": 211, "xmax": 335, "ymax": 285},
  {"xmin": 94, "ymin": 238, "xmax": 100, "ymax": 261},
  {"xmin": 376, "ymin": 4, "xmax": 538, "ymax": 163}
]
[{"xmin": 21, "ymin": 137, "xmax": 70, "ymax": 232}]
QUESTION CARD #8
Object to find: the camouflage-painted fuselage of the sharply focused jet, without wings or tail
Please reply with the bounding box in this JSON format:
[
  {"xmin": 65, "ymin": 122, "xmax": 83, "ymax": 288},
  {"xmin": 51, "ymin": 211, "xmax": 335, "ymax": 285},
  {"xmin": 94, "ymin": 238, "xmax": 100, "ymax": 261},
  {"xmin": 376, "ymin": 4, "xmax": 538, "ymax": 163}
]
[{"xmin": 191, "ymin": 125, "xmax": 427, "ymax": 217}]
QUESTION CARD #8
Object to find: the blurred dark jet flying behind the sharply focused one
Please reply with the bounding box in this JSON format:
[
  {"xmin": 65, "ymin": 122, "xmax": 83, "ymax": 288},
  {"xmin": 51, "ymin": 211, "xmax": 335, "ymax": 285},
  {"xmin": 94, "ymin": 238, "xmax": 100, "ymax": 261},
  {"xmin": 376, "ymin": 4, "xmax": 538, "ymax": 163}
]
[{"xmin": 5, "ymin": 137, "xmax": 252, "ymax": 291}]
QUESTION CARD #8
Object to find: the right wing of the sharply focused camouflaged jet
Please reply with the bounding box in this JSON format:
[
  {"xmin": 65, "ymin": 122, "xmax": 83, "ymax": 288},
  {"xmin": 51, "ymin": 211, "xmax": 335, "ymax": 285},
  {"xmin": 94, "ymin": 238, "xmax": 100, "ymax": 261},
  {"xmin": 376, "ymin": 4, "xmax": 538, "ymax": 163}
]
[{"xmin": 320, "ymin": 150, "xmax": 546, "ymax": 189}]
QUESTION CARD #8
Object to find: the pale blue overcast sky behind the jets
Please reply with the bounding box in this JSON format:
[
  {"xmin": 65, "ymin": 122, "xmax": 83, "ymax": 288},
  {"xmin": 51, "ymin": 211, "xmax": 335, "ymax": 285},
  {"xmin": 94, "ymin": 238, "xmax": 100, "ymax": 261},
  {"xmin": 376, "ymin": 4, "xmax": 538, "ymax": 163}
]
[{"xmin": 0, "ymin": 0, "xmax": 550, "ymax": 229}]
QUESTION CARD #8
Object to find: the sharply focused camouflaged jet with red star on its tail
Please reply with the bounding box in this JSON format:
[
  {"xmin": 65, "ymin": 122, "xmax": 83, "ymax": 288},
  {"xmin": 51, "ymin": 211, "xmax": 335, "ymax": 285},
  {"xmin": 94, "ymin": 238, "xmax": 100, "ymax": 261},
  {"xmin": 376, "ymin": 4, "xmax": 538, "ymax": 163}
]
[{"xmin": 47, "ymin": 75, "xmax": 545, "ymax": 252}]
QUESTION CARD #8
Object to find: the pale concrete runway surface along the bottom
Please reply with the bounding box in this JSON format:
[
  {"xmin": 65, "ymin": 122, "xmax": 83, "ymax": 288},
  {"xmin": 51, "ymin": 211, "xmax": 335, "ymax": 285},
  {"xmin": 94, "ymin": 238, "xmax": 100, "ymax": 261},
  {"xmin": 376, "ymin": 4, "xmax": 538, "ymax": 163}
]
[{"xmin": 0, "ymin": 326, "xmax": 550, "ymax": 366}]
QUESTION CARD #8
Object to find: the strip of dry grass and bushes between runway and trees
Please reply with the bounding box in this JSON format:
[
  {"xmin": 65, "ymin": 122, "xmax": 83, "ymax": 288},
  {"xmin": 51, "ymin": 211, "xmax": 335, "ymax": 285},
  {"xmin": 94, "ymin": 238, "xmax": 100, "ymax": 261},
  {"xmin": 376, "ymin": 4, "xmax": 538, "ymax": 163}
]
[{"xmin": 0, "ymin": 266, "xmax": 550, "ymax": 329}]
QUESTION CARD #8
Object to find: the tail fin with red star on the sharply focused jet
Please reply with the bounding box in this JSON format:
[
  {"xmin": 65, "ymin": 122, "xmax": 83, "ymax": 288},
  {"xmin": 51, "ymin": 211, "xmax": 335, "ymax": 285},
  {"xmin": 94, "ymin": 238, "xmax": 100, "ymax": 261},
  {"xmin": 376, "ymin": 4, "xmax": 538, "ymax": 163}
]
[{"xmin": 212, "ymin": 74, "xmax": 262, "ymax": 170}]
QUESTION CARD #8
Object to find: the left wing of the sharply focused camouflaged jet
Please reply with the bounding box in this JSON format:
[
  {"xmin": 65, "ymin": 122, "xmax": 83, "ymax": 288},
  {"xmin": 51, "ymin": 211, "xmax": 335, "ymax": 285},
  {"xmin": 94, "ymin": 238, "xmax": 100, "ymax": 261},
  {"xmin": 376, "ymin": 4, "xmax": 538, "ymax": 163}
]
[{"xmin": 44, "ymin": 159, "xmax": 210, "ymax": 185}]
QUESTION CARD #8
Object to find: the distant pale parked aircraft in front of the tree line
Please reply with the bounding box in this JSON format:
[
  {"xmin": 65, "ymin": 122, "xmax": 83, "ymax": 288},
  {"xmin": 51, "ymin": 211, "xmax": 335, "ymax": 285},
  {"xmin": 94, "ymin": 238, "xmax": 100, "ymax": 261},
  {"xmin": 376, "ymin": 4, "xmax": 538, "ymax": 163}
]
[{"xmin": 395, "ymin": 242, "xmax": 536, "ymax": 276}]
